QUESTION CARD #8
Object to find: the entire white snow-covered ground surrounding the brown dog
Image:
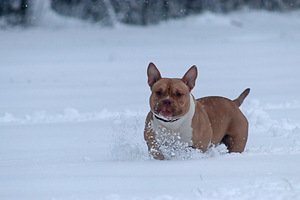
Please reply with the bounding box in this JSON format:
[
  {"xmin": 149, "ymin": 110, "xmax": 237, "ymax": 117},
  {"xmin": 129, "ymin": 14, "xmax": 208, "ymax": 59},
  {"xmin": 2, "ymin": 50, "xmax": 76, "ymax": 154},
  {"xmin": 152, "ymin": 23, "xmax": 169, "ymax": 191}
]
[{"xmin": 0, "ymin": 11, "xmax": 300, "ymax": 200}]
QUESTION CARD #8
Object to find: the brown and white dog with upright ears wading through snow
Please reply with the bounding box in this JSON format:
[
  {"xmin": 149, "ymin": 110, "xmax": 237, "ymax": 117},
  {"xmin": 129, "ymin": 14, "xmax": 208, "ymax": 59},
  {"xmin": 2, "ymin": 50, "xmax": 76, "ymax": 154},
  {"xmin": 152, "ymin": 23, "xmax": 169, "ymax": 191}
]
[{"xmin": 144, "ymin": 63, "xmax": 250, "ymax": 160}]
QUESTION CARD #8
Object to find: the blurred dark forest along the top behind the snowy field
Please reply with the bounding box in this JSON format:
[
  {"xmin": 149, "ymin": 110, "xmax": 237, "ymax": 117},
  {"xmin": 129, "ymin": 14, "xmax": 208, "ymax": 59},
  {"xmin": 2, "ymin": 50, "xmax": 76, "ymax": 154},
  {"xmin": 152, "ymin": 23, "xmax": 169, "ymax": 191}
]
[{"xmin": 0, "ymin": 0, "xmax": 300, "ymax": 27}]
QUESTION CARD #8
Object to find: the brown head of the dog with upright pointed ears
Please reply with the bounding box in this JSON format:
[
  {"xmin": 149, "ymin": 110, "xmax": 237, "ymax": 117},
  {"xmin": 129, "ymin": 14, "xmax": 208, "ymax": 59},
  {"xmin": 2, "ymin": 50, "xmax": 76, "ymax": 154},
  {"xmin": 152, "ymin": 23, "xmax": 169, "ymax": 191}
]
[{"xmin": 147, "ymin": 63, "xmax": 197, "ymax": 120}]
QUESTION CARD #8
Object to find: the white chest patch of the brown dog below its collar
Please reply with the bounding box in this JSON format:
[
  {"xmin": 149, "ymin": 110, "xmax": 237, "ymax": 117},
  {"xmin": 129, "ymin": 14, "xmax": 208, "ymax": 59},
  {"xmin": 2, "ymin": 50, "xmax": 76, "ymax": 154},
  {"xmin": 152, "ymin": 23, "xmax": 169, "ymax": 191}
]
[{"xmin": 151, "ymin": 94, "xmax": 195, "ymax": 146}]
